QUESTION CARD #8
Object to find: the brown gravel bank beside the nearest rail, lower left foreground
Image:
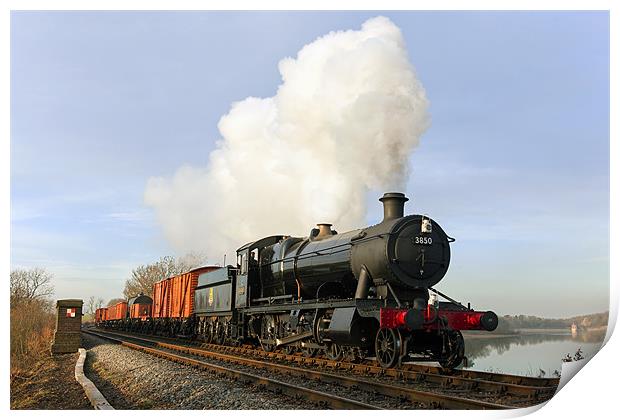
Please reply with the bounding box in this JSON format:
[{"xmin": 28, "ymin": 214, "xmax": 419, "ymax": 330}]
[{"xmin": 82, "ymin": 334, "xmax": 319, "ymax": 410}]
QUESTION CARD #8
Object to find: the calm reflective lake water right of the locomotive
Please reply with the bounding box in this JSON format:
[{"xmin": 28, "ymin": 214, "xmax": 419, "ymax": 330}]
[{"xmin": 464, "ymin": 330, "xmax": 605, "ymax": 377}]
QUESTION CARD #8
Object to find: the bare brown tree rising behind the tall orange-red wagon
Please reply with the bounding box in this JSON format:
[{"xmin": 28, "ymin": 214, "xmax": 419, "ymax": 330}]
[{"xmin": 123, "ymin": 254, "xmax": 206, "ymax": 299}]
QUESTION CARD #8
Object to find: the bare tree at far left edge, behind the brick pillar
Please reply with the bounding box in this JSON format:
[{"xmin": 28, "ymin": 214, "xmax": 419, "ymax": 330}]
[{"xmin": 10, "ymin": 268, "xmax": 54, "ymax": 307}]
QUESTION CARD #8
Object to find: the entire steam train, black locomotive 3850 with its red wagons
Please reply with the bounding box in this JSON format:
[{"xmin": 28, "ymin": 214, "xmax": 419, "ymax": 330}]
[{"xmin": 96, "ymin": 193, "xmax": 498, "ymax": 368}]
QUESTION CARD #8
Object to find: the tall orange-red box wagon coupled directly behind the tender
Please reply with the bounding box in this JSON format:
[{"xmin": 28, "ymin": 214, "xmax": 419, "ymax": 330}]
[{"xmin": 153, "ymin": 266, "xmax": 219, "ymax": 318}]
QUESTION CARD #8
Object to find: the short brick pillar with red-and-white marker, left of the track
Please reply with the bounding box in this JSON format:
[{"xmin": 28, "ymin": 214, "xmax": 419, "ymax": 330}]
[{"xmin": 52, "ymin": 299, "xmax": 83, "ymax": 353}]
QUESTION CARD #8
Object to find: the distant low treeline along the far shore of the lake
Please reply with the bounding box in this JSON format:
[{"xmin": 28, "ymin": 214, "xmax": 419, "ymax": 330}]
[{"xmin": 496, "ymin": 312, "xmax": 609, "ymax": 332}]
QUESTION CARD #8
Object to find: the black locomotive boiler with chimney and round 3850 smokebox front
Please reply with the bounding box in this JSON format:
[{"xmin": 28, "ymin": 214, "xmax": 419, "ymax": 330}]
[{"xmin": 260, "ymin": 193, "xmax": 453, "ymax": 308}]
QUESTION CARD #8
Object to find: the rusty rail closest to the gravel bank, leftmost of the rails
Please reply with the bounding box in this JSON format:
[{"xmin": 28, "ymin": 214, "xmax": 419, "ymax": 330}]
[{"xmin": 82, "ymin": 330, "xmax": 381, "ymax": 410}]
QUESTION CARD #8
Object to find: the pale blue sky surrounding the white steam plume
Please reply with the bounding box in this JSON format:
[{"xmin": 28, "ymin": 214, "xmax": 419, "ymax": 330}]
[{"xmin": 11, "ymin": 12, "xmax": 609, "ymax": 316}]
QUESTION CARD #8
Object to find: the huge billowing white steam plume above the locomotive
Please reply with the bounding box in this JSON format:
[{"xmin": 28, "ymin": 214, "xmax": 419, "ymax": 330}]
[{"xmin": 145, "ymin": 17, "xmax": 429, "ymax": 261}]
